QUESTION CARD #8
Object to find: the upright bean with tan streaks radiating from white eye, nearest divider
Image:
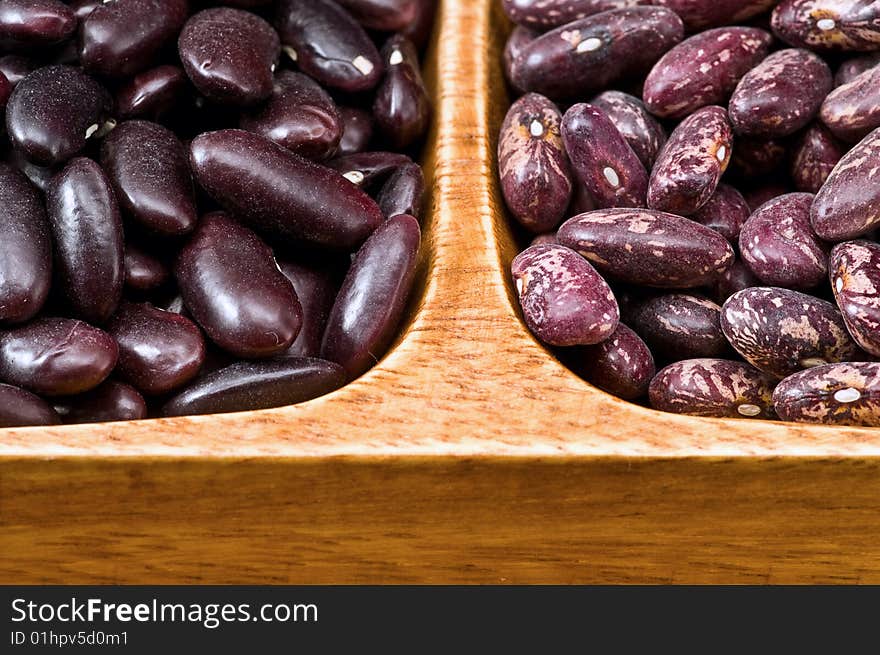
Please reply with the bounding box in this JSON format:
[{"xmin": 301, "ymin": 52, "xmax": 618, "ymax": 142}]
[{"xmin": 498, "ymin": 93, "xmax": 572, "ymax": 232}]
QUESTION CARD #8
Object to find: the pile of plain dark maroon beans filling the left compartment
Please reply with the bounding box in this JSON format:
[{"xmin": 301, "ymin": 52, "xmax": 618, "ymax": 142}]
[{"xmin": 0, "ymin": 0, "xmax": 435, "ymax": 427}]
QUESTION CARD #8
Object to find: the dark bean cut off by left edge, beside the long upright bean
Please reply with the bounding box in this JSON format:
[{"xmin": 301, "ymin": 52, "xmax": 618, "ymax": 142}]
[{"xmin": 0, "ymin": 163, "xmax": 52, "ymax": 323}]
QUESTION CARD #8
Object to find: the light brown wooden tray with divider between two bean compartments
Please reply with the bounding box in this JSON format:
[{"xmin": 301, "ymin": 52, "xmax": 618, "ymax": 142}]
[{"xmin": 0, "ymin": 0, "xmax": 880, "ymax": 583}]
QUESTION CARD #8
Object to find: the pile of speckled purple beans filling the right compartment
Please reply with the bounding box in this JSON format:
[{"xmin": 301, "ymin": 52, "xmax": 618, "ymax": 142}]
[{"xmin": 506, "ymin": 0, "xmax": 880, "ymax": 426}]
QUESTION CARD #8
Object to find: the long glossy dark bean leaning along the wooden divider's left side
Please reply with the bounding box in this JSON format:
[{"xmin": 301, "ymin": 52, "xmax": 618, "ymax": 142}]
[{"xmin": 321, "ymin": 214, "xmax": 421, "ymax": 379}]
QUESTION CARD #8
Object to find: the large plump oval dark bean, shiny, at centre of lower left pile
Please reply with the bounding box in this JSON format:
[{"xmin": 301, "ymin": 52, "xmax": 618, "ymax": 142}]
[{"xmin": 174, "ymin": 212, "xmax": 302, "ymax": 358}]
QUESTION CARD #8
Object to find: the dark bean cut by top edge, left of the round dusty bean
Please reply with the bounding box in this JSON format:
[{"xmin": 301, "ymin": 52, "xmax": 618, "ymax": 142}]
[{"xmin": 79, "ymin": 0, "xmax": 189, "ymax": 77}]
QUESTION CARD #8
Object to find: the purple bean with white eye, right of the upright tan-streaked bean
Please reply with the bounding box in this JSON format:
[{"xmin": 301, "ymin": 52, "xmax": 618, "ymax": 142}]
[{"xmin": 564, "ymin": 103, "xmax": 648, "ymax": 209}]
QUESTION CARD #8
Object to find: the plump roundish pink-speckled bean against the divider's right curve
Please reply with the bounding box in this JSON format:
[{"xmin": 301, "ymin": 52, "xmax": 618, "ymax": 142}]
[{"xmin": 511, "ymin": 245, "xmax": 620, "ymax": 346}]
